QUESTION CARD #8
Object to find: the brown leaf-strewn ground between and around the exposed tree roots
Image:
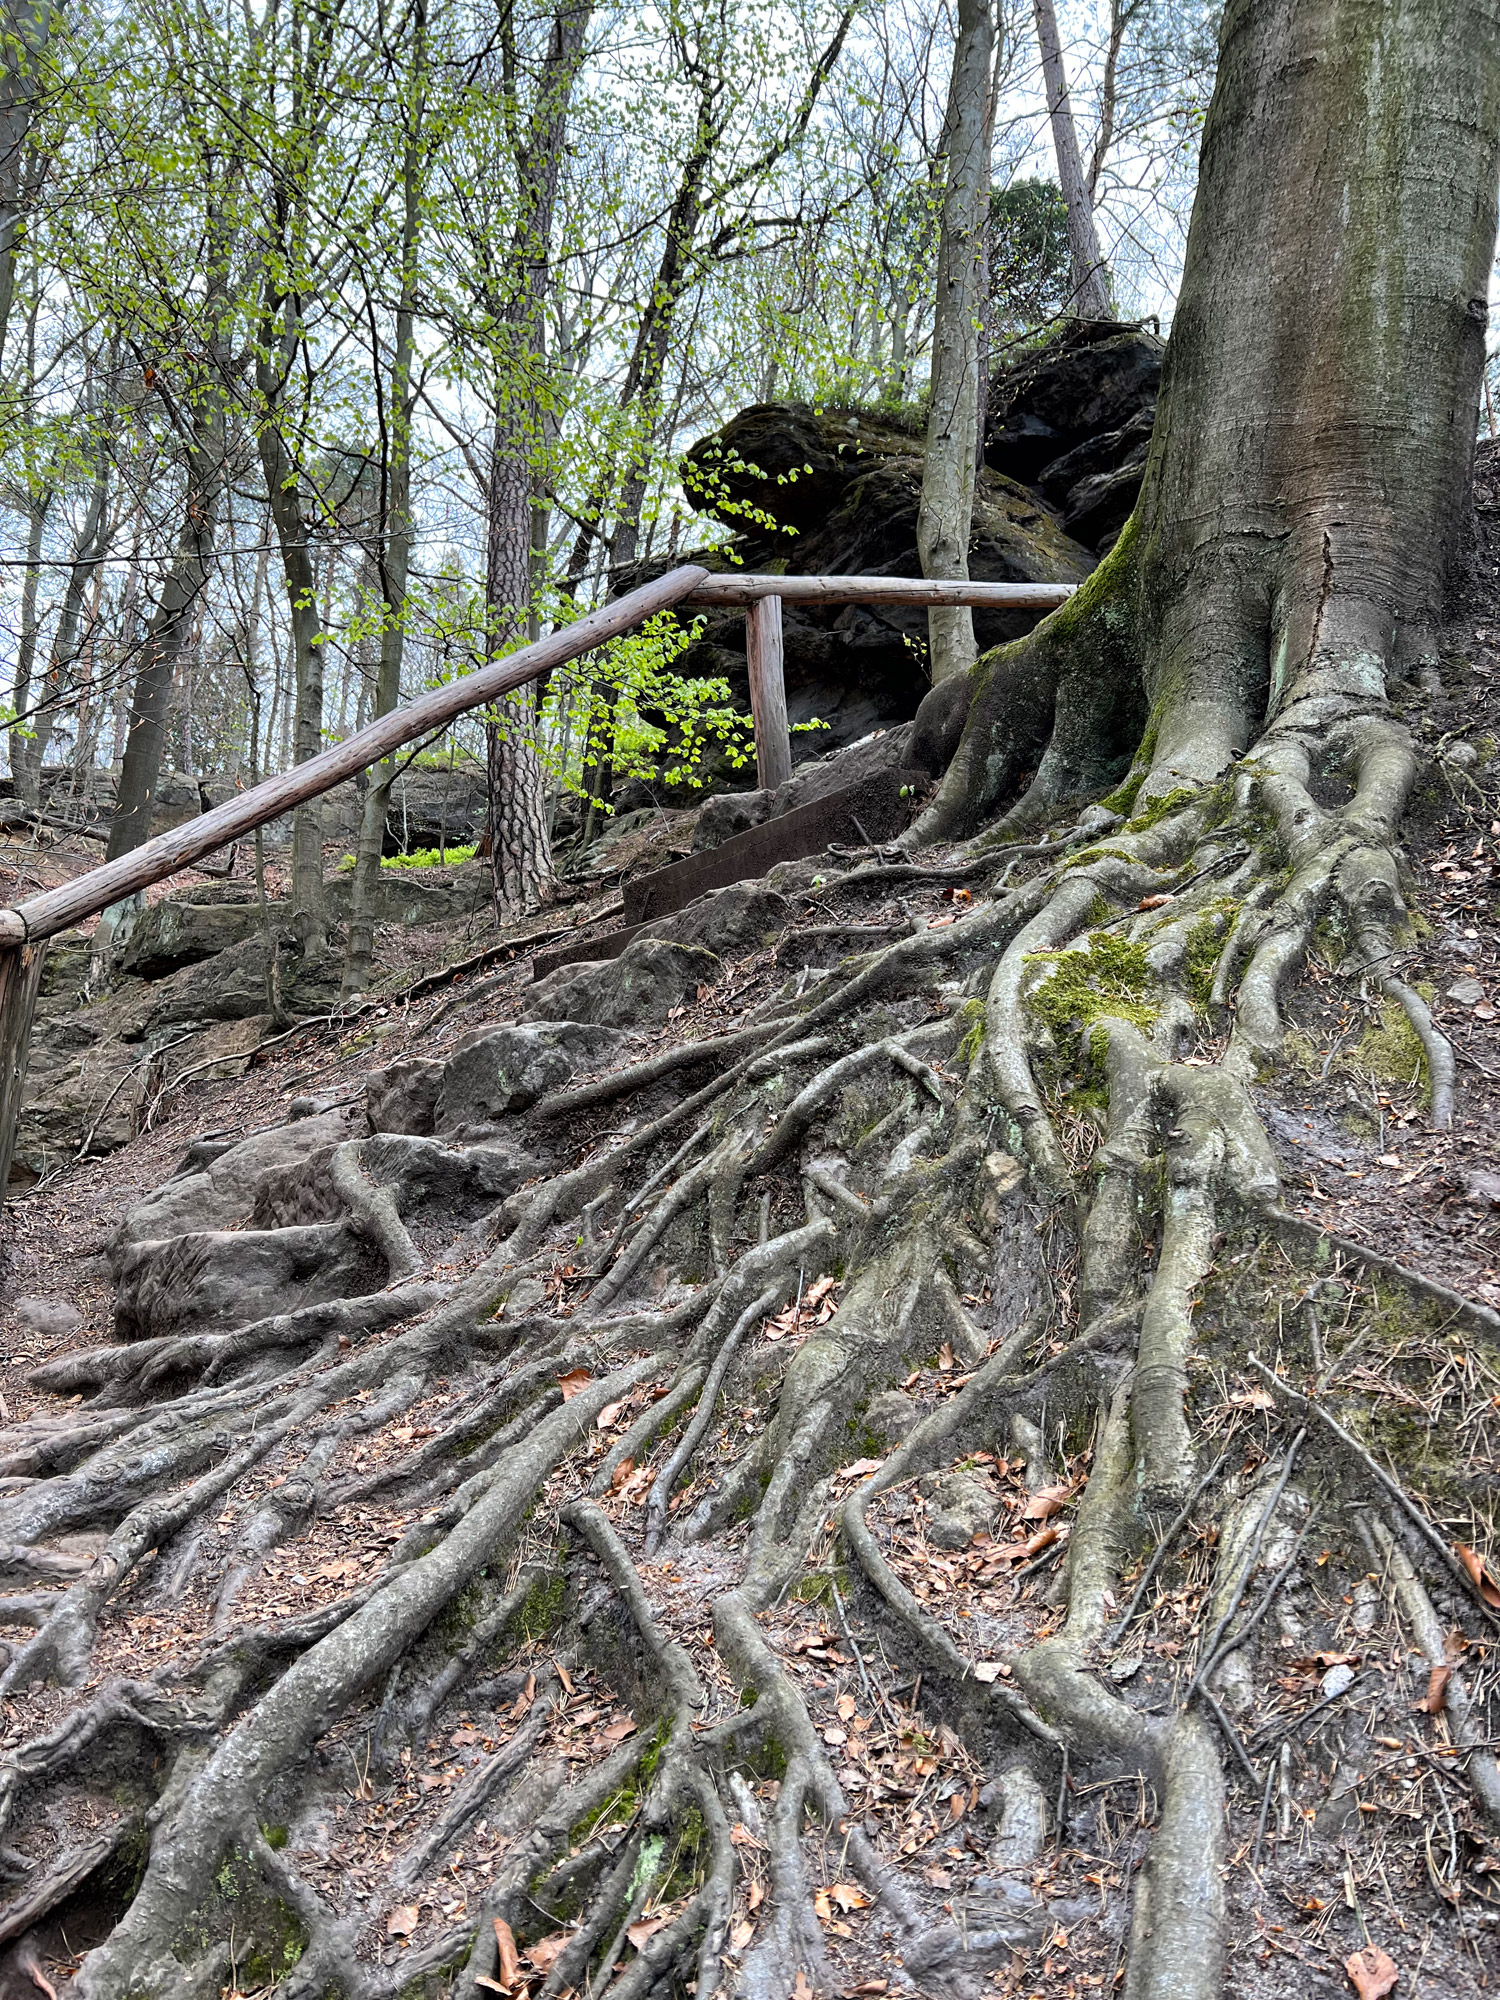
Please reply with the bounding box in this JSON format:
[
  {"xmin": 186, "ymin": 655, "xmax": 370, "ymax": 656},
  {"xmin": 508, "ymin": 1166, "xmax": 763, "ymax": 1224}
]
[{"xmin": 0, "ymin": 500, "xmax": 1500, "ymax": 2000}]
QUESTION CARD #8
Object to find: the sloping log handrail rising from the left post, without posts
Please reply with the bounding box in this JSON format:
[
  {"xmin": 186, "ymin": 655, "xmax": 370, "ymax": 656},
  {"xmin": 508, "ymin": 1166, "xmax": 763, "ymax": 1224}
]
[{"xmin": 0, "ymin": 562, "xmax": 708, "ymax": 946}]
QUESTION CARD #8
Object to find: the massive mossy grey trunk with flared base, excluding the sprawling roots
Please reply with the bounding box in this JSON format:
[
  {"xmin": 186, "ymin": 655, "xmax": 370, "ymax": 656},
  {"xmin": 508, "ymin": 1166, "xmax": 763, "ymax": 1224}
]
[{"xmin": 928, "ymin": 0, "xmax": 1500, "ymax": 832}]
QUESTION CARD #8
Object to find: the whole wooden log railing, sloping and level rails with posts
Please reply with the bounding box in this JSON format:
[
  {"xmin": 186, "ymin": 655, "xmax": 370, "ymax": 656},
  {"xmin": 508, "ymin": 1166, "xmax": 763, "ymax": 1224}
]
[{"xmin": 0, "ymin": 562, "xmax": 1074, "ymax": 1200}]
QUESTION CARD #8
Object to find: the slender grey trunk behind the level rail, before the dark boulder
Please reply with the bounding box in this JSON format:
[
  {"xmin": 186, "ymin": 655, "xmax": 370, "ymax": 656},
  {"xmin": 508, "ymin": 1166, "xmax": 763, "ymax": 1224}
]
[{"xmin": 916, "ymin": 0, "xmax": 994, "ymax": 684}]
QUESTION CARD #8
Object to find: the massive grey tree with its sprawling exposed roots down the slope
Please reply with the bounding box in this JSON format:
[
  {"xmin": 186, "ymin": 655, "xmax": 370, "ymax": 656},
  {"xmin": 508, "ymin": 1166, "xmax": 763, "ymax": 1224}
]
[{"xmin": 0, "ymin": 0, "xmax": 1500, "ymax": 2000}]
